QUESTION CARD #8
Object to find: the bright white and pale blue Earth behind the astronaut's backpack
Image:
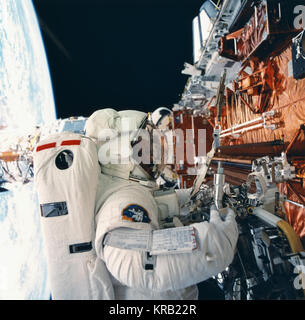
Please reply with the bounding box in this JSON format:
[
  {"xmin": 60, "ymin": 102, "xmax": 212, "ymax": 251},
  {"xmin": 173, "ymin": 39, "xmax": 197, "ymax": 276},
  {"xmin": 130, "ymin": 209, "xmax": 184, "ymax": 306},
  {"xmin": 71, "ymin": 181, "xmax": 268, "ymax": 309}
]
[{"xmin": 0, "ymin": 0, "xmax": 56, "ymax": 300}]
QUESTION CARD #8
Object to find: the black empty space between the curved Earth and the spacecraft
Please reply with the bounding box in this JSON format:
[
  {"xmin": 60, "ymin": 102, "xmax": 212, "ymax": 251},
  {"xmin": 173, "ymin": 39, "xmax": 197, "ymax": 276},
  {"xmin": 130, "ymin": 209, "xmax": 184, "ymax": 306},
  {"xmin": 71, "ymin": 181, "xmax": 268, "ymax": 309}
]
[{"xmin": 33, "ymin": 0, "xmax": 203, "ymax": 118}]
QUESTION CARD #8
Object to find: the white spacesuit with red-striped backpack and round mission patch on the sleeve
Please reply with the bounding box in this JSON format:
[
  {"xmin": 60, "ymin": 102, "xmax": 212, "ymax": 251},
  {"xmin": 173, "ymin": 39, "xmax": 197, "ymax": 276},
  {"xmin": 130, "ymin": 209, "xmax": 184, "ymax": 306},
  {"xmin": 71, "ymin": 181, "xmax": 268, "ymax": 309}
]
[{"xmin": 34, "ymin": 109, "xmax": 238, "ymax": 300}]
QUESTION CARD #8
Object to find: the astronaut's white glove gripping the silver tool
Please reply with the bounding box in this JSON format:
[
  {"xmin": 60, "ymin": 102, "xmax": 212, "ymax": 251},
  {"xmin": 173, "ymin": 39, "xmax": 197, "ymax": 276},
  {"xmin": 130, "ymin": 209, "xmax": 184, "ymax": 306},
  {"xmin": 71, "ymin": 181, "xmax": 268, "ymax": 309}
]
[{"xmin": 210, "ymin": 205, "xmax": 238, "ymax": 248}]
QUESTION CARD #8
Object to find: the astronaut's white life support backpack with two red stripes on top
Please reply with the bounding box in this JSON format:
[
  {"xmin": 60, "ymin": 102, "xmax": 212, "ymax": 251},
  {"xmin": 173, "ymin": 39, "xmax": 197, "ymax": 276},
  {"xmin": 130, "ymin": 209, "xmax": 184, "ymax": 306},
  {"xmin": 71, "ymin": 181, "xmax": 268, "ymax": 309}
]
[{"xmin": 34, "ymin": 132, "xmax": 114, "ymax": 299}]
